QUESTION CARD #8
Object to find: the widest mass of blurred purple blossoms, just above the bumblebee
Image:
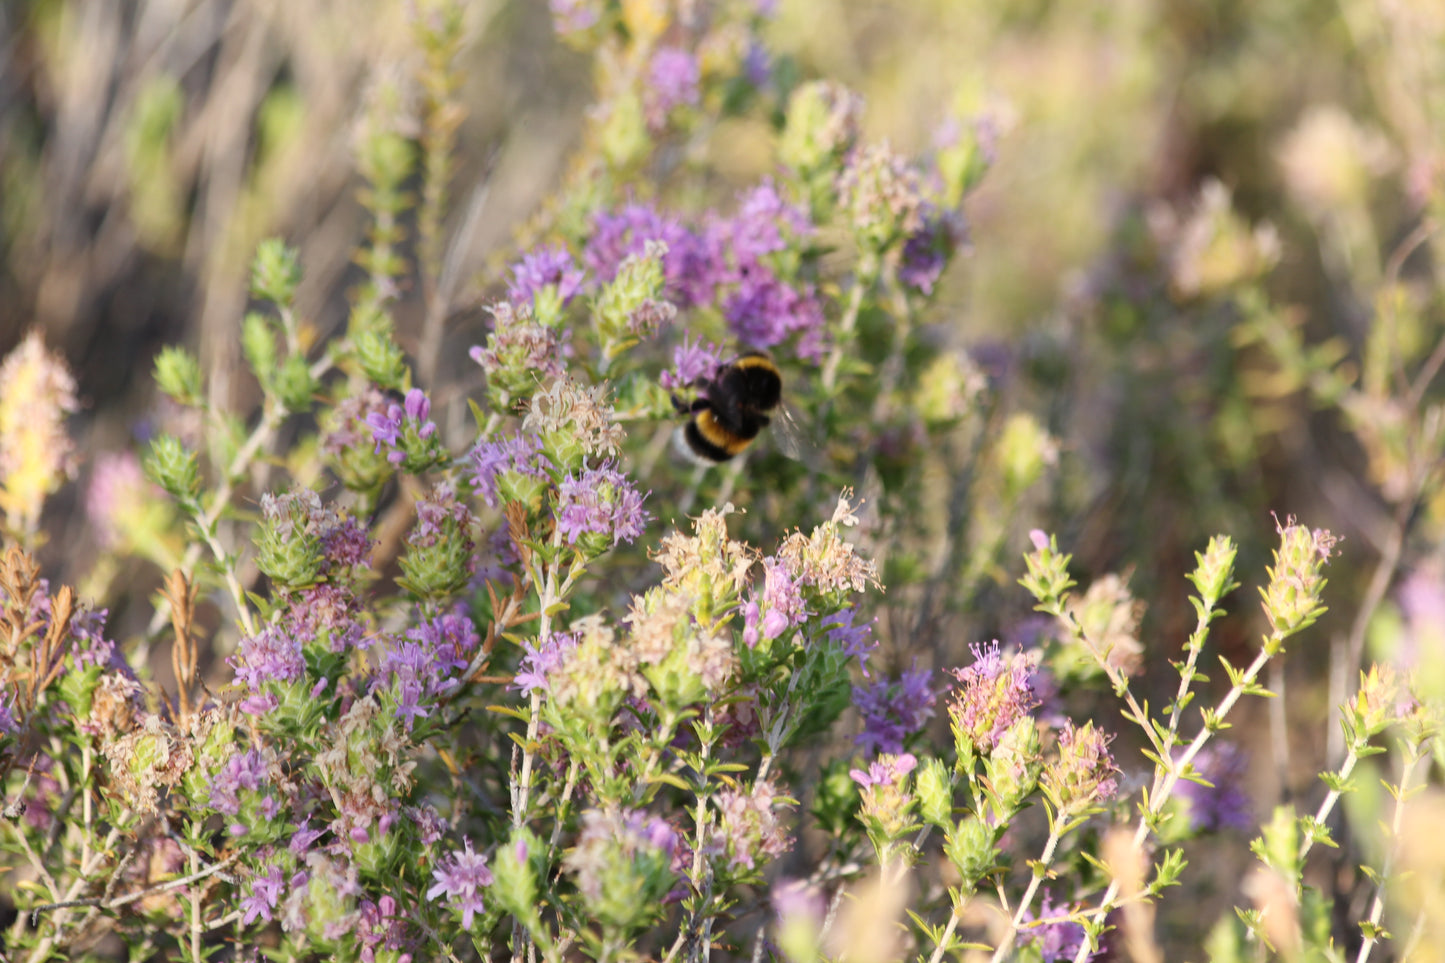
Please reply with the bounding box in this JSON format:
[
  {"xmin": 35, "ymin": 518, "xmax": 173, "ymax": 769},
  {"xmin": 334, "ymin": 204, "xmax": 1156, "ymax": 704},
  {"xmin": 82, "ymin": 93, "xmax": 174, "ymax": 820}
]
[{"xmin": 585, "ymin": 182, "xmax": 824, "ymax": 352}]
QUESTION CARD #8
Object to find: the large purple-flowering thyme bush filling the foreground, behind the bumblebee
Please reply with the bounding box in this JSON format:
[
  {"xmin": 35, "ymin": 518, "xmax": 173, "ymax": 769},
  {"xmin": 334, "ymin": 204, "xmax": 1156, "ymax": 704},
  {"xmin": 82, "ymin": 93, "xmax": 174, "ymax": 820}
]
[{"xmin": 0, "ymin": 0, "xmax": 1436, "ymax": 963}]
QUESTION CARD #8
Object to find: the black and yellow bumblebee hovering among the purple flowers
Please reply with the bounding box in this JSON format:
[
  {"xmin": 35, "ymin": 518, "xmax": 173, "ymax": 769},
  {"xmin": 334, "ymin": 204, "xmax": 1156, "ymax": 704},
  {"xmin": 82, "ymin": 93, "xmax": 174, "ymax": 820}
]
[{"xmin": 672, "ymin": 351, "xmax": 786, "ymax": 464}]
